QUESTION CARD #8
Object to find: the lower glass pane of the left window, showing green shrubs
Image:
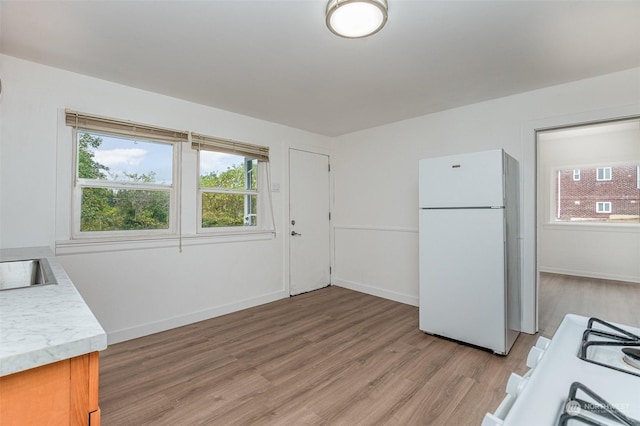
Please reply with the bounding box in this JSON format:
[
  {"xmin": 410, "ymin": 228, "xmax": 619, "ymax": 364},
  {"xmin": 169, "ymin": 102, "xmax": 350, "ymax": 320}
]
[{"xmin": 80, "ymin": 188, "xmax": 170, "ymax": 232}]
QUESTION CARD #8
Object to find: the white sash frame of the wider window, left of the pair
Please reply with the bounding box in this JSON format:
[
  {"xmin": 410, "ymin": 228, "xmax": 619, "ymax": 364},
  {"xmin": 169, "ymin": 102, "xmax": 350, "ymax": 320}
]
[{"xmin": 71, "ymin": 127, "xmax": 180, "ymax": 239}]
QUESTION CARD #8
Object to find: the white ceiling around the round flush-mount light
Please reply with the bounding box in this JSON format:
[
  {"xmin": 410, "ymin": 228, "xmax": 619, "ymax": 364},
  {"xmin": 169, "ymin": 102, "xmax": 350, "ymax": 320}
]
[{"xmin": 0, "ymin": 0, "xmax": 640, "ymax": 136}]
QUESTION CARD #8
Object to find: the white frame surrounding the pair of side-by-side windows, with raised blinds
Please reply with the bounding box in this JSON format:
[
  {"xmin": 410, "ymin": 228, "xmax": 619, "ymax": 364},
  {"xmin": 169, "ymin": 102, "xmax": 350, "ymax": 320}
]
[{"xmin": 55, "ymin": 109, "xmax": 276, "ymax": 254}]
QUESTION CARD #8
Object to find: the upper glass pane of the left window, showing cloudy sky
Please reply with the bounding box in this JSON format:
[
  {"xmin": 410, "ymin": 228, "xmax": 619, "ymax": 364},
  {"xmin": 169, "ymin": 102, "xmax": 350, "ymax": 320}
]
[{"xmin": 78, "ymin": 130, "xmax": 173, "ymax": 185}]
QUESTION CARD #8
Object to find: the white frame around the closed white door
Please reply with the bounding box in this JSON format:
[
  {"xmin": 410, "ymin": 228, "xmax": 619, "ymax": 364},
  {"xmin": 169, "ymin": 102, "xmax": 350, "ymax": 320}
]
[{"xmin": 283, "ymin": 144, "xmax": 335, "ymax": 297}]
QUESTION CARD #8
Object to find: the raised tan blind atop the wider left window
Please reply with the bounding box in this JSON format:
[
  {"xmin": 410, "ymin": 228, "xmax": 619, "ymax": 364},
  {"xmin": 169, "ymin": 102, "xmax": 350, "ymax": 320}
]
[{"xmin": 65, "ymin": 109, "xmax": 189, "ymax": 142}]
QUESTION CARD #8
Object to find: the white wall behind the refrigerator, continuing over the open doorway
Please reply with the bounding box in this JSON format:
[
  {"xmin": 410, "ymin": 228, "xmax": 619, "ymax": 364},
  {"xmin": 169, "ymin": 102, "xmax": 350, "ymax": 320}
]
[{"xmin": 332, "ymin": 69, "xmax": 640, "ymax": 332}]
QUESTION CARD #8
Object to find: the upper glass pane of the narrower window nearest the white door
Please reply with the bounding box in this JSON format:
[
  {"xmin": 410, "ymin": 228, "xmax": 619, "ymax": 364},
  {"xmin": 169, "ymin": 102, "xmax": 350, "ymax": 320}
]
[{"xmin": 199, "ymin": 150, "xmax": 258, "ymax": 191}]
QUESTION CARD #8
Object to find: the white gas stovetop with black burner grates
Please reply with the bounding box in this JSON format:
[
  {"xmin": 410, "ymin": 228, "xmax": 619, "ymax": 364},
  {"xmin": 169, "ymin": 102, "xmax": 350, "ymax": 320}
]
[{"xmin": 504, "ymin": 315, "xmax": 640, "ymax": 426}]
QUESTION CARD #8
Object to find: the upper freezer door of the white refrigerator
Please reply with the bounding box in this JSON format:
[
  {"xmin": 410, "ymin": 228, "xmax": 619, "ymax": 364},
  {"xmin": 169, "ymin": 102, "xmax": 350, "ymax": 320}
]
[{"xmin": 419, "ymin": 149, "xmax": 504, "ymax": 208}]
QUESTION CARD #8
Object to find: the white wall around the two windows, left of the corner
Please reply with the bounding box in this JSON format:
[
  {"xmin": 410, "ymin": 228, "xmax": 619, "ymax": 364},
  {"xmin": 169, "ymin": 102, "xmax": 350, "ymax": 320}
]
[{"xmin": 0, "ymin": 56, "xmax": 329, "ymax": 343}]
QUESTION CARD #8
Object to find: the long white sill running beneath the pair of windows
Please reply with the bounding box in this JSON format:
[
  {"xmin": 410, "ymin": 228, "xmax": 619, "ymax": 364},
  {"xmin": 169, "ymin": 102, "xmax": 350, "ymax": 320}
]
[{"xmin": 55, "ymin": 231, "xmax": 276, "ymax": 256}]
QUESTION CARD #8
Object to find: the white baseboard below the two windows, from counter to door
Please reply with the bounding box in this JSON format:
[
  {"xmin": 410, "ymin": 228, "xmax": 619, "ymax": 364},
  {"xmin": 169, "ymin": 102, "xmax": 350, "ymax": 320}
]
[{"xmin": 107, "ymin": 290, "xmax": 289, "ymax": 345}]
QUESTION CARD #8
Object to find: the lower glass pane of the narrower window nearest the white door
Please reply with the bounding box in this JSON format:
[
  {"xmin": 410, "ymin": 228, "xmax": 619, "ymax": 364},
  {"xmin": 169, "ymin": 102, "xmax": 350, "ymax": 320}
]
[{"xmin": 202, "ymin": 192, "xmax": 258, "ymax": 228}]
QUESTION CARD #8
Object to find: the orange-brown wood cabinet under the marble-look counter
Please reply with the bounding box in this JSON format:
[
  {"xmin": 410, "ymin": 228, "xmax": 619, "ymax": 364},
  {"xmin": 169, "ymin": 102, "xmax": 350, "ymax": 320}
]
[{"xmin": 0, "ymin": 352, "xmax": 100, "ymax": 426}]
